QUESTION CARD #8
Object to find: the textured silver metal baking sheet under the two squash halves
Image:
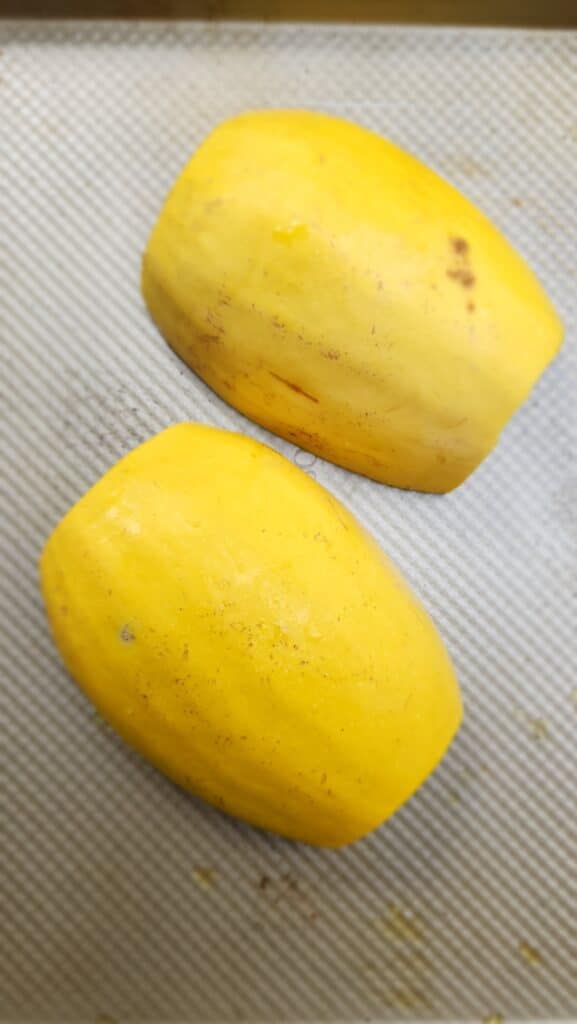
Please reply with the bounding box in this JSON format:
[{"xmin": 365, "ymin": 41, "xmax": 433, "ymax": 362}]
[{"xmin": 0, "ymin": 24, "xmax": 577, "ymax": 1022}]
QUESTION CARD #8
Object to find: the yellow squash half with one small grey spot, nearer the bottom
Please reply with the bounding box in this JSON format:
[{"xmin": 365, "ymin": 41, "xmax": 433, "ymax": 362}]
[{"xmin": 41, "ymin": 424, "xmax": 461, "ymax": 846}]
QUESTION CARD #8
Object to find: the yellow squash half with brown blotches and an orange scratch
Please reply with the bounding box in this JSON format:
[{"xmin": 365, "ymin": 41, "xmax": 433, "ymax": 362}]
[{"xmin": 142, "ymin": 111, "xmax": 562, "ymax": 492}]
